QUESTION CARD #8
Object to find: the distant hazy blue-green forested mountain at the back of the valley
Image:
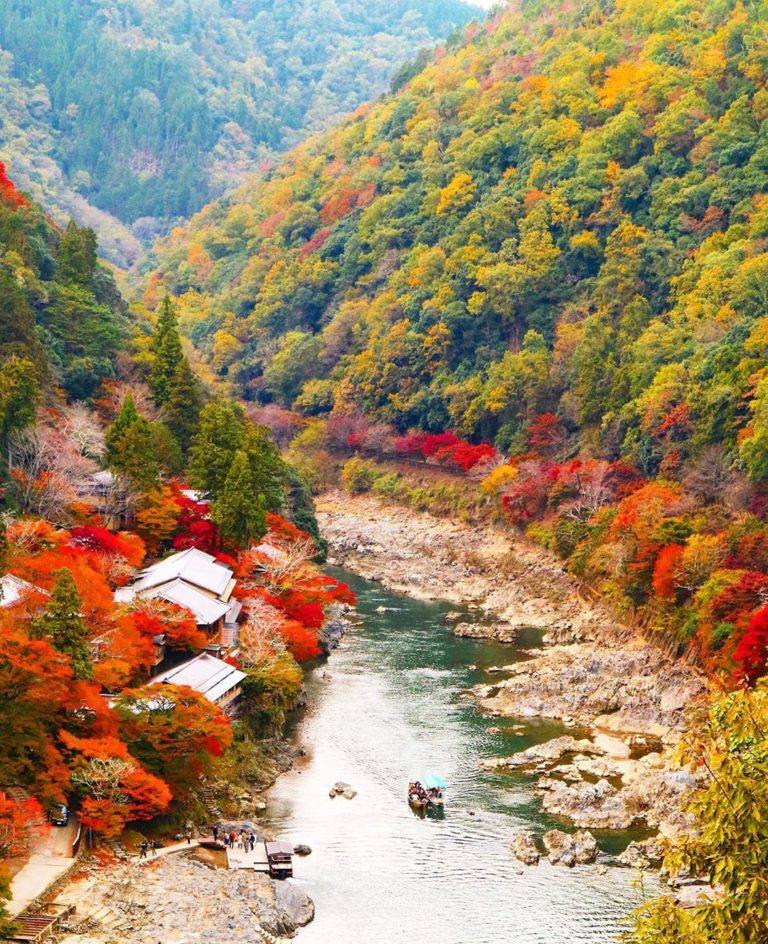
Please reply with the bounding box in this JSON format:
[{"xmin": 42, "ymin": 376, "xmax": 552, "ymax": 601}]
[{"xmin": 0, "ymin": 0, "xmax": 478, "ymax": 264}]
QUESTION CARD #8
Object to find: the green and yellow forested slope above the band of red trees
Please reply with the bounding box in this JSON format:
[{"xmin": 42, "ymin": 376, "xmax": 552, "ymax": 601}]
[{"xmin": 150, "ymin": 0, "xmax": 768, "ymax": 473}]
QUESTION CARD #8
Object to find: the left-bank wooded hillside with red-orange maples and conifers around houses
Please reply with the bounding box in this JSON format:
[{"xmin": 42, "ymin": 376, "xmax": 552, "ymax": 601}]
[{"xmin": 0, "ymin": 164, "xmax": 353, "ymax": 940}]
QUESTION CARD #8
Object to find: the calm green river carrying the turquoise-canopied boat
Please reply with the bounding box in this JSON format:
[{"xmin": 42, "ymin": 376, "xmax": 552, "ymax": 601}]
[{"xmin": 269, "ymin": 572, "xmax": 655, "ymax": 944}]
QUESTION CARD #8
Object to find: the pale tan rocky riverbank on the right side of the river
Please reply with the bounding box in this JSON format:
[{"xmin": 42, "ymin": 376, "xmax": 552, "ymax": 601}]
[{"xmin": 317, "ymin": 493, "xmax": 707, "ymax": 848}]
